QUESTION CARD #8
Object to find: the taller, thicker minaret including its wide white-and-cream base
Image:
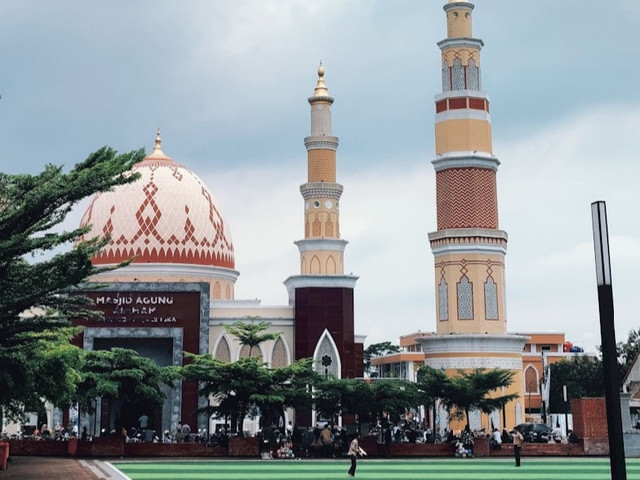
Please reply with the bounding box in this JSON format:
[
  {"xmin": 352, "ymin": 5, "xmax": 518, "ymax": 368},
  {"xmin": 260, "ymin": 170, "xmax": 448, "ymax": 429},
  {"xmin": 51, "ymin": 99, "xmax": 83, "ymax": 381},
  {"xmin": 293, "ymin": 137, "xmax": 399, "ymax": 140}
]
[{"xmin": 419, "ymin": 0, "xmax": 527, "ymax": 429}]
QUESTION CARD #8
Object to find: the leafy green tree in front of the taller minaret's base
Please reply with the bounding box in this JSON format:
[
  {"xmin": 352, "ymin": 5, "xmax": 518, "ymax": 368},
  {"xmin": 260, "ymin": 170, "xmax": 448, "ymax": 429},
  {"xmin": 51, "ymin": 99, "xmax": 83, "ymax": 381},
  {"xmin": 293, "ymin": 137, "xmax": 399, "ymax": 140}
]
[{"xmin": 421, "ymin": 366, "xmax": 518, "ymax": 430}]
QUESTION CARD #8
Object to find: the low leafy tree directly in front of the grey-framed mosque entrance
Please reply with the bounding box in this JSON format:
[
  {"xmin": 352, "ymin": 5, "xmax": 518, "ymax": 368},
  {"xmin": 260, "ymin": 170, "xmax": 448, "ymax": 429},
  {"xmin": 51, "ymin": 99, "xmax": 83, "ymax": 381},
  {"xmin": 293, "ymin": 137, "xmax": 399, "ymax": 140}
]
[{"xmin": 74, "ymin": 348, "xmax": 179, "ymax": 412}]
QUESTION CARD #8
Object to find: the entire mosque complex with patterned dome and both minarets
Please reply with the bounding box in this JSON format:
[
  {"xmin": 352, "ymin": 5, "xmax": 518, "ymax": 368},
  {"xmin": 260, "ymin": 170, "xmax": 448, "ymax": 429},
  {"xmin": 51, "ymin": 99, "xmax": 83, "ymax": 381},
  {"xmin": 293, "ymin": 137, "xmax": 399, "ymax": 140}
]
[{"xmin": 61, "ymin": 0, "xmax": 576, "ymax": 431}]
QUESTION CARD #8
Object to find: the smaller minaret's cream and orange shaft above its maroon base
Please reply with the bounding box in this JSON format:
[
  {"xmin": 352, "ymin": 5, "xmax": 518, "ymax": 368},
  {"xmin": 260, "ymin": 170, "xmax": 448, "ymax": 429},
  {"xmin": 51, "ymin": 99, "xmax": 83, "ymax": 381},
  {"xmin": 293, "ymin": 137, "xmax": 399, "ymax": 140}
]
[{"xmin": 295, "ymin": 63, "xmax": 348, "ymax": 275}]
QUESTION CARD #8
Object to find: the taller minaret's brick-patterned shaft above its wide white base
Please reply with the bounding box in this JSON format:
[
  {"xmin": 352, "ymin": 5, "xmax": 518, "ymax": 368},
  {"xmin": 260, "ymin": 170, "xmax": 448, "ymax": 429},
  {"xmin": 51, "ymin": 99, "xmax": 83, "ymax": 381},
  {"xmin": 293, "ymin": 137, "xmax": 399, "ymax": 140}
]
[{"xmin": 429, "ymin": 1, "xmax": 507, "ymax": 334}]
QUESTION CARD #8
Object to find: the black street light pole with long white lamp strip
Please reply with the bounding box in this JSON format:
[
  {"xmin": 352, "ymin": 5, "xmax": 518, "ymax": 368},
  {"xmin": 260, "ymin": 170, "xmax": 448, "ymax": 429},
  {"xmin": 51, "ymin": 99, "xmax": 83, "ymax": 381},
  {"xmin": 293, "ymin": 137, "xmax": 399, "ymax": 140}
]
[{"xmin": 591, "ymin": 201, "xmax": 627, "ymax": 480}]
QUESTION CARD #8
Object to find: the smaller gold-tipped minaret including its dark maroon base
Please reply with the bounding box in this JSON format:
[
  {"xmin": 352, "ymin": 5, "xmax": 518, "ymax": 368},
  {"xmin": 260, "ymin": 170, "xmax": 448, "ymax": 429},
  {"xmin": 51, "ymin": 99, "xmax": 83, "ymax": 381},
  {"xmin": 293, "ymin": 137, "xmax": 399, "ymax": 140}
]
[{"xmin": 284, "ymin": 64, "xmax": 363, "ymax": 410}]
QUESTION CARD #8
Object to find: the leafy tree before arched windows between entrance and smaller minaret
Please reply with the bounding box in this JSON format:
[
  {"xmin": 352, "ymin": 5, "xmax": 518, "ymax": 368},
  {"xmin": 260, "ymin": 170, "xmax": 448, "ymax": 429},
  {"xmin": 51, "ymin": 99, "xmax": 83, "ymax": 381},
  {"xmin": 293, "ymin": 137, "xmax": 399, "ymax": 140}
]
[{"xmin": 182, "ymin": 353, "xmax": 317, "ymax": 435}]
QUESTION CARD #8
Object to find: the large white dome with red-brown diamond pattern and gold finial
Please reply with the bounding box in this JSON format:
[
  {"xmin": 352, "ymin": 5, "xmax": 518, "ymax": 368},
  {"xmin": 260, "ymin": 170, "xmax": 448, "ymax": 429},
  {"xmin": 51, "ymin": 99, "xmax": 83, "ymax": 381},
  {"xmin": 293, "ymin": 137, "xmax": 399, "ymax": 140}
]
[{"xmin": 81, "ymin": 132, "xmax": 235, "ymax": 269}]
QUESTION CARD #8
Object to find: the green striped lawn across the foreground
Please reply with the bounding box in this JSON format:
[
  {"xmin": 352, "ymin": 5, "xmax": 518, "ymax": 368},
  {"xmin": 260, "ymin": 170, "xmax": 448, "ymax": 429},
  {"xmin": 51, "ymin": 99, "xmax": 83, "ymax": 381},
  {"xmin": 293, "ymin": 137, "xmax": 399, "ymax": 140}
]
[{"xmin": 112, "ymin": 457, "xmax": 640, "ymax": 480}]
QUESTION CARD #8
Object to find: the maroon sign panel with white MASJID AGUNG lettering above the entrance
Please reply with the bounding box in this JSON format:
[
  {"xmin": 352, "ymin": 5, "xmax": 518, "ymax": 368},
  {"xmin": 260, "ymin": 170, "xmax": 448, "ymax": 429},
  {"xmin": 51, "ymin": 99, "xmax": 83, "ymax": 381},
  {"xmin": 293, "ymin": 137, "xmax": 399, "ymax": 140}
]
[{"xmin": 81, "ymin": 291, "xmax": 200, "ymax": 327}]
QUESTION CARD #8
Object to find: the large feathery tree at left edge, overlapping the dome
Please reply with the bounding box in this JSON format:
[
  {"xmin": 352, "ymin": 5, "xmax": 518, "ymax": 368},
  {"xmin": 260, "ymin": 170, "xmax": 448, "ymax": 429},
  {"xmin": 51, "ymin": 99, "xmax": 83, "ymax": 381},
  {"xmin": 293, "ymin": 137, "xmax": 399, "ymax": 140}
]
[{"xmin": 0, "ymin": 147, "xmax": 144, "ymax": 415}]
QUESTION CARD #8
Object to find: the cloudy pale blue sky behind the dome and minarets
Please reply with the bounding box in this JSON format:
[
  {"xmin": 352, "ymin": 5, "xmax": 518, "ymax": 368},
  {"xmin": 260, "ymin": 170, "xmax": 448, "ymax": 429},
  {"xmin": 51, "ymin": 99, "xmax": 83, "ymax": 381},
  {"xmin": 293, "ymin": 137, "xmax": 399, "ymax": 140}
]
[{"xmin": 0, "ymin": 0, "xmax": 640, "ymax": 351}]
